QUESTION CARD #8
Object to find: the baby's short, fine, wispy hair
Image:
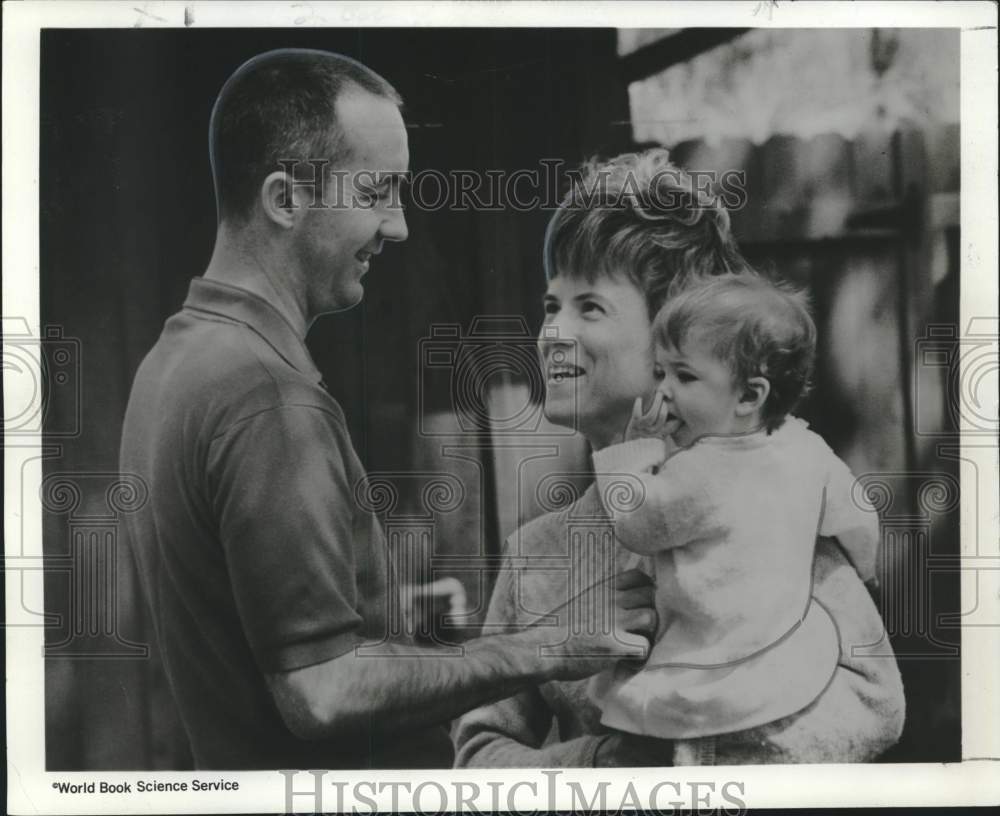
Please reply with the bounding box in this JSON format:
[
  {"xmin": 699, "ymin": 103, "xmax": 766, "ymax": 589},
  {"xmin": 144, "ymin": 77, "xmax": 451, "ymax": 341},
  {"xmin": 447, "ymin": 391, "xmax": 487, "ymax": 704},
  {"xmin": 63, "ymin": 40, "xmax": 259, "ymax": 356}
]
[{"xmin": 653, "ymin": 273, "xmax": 816, "ymax": 432}]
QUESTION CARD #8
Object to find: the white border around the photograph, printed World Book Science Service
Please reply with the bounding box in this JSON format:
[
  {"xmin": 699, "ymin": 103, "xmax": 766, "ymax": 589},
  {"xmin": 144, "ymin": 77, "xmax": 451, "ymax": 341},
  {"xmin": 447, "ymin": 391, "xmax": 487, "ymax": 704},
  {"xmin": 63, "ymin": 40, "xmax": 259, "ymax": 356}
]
[{"xmin": 3, "ymin": 2, "xmax": 1000, "ymax": 814}]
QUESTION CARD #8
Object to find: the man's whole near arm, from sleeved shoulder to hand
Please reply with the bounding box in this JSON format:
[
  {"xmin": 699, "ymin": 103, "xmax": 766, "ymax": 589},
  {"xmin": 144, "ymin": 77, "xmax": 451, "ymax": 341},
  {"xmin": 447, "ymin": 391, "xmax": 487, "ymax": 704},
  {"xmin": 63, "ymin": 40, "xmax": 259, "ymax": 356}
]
[{"xmin": 209, "ymin": 404, "xmax": 656, "ymax": 738}]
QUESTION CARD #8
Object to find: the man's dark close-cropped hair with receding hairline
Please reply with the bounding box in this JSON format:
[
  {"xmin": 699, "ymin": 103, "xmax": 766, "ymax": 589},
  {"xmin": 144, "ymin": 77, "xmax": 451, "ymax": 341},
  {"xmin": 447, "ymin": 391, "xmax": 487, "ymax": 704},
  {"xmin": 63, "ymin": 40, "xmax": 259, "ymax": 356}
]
[{"xmin": 209, "ymin": 48, "xmax": 402, "ymax": 221}]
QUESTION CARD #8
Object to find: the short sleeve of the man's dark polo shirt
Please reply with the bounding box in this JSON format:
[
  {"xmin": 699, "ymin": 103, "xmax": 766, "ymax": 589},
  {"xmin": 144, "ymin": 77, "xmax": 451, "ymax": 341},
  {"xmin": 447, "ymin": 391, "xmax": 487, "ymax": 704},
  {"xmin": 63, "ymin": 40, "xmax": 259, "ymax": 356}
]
[{"xmin": 208, "ymin": 405, "xmax": 362, "ymax": 672}]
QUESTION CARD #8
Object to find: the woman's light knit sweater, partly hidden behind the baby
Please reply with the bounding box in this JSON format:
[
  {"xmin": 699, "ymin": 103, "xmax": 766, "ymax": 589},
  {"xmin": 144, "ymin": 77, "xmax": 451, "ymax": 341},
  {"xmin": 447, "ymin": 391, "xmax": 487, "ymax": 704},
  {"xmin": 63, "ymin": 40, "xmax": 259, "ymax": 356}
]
[{"xmin": 453, "ymin": 472, "xmax": 904, "ymax": 768}]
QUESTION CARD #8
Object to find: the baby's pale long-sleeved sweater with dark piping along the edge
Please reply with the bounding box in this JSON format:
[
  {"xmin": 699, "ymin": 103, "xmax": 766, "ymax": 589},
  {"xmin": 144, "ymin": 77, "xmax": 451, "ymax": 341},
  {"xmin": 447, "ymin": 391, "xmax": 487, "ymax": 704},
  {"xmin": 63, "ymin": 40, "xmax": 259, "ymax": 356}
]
[{"xmin": 591, "ymin": 418, "xmax": 878, "ymax": 738}]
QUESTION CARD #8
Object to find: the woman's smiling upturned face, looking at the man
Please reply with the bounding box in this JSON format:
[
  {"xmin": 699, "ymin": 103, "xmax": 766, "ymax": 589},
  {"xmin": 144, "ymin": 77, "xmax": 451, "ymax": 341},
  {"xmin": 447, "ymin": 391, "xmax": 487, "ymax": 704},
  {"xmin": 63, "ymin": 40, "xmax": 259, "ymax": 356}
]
[{"xmin": 538, "ymin": 275, "xmax": 656, "ymax": 449}]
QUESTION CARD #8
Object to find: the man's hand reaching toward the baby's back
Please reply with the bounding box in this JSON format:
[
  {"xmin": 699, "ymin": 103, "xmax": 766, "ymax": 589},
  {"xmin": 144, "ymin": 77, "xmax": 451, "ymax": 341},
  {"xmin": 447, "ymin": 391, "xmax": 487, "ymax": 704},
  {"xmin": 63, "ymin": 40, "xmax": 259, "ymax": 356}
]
[{"xmin": 533, "ymin": 569, "xmax": 657, "ymax": 680}]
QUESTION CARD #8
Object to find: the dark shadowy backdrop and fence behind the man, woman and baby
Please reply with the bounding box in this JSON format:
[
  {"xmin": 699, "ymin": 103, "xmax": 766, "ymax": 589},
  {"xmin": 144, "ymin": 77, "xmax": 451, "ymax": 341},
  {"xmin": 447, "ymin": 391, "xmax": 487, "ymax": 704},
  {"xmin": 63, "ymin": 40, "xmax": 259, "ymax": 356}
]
[{"xmin": 40, "ymin": 29, "xmax": 960, "ymax": 770}]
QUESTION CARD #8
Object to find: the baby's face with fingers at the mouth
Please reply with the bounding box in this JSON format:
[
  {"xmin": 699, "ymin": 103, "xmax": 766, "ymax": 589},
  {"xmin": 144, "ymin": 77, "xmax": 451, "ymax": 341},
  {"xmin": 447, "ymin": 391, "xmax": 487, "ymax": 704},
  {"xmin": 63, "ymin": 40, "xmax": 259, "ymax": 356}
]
[{"xmin": 656, "ymin": 334, "xmax": 743, "ymax": 447}]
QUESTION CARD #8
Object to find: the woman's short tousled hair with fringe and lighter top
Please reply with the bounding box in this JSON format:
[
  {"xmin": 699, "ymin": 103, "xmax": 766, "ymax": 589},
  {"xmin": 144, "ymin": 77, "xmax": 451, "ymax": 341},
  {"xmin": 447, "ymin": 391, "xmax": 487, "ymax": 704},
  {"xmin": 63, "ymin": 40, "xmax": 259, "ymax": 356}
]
[{"xmin": 544, "ymin": 148, "xmax": 752, "ymax": 318}]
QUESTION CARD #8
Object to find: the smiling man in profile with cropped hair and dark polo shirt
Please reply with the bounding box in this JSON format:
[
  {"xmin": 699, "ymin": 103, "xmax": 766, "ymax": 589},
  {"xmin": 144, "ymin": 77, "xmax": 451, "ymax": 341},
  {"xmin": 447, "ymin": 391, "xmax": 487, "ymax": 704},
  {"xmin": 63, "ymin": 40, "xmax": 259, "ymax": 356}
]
[{"xmin": 121, "ymin": 50, "xmax": 655, "ymax": 769}]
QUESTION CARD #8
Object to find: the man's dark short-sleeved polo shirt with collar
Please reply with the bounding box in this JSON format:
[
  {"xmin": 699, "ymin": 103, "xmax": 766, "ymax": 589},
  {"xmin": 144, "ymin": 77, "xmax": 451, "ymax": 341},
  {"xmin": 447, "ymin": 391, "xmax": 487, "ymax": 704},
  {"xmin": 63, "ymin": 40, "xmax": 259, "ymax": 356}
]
[{"xmin": 121, "ymin": 278, "xmax": 452, "ymax": 769}]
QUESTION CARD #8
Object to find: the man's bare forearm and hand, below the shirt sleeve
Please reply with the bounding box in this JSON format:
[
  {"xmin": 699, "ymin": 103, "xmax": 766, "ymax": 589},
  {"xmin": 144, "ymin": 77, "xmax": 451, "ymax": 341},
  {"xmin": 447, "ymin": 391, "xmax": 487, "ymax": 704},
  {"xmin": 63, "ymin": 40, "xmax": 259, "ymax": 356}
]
[{"xmin": 268, "ymin": 570, "xmax": 656, "ymax": 739}]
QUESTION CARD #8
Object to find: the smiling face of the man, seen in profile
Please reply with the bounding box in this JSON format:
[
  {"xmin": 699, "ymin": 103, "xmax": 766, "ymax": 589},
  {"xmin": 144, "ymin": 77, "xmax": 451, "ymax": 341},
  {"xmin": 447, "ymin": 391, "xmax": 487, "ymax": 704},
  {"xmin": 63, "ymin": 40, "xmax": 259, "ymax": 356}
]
[{"xmin": 295, "ymin": 90, "xmax": 410, "ymax": 319}]
